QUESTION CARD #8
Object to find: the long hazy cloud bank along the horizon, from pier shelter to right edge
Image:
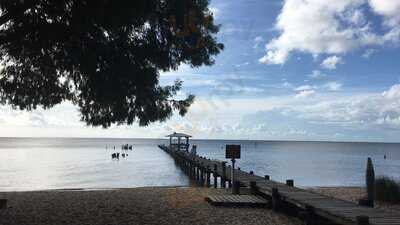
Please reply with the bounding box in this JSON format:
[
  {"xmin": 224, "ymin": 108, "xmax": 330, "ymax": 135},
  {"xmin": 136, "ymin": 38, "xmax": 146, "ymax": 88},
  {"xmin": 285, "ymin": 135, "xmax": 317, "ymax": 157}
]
[{"xmin": 173, "ymin": 84, "xmax": 400, "ymax": 141}]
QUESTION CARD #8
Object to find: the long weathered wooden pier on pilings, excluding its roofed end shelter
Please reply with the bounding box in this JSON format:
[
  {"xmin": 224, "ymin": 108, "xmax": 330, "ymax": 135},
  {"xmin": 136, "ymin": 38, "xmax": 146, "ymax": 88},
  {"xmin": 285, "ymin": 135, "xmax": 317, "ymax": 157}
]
[{"xmin": 159, "ymin": 145, "xmax": 400, "ymax": 225}]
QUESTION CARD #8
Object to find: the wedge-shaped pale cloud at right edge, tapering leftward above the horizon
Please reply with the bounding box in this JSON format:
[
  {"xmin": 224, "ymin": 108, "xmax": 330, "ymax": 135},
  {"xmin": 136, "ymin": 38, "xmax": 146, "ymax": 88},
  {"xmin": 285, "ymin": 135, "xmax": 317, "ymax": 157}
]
[{"xmin": 296, "ymin": 84, "xmax": 400, "ymax": 130}]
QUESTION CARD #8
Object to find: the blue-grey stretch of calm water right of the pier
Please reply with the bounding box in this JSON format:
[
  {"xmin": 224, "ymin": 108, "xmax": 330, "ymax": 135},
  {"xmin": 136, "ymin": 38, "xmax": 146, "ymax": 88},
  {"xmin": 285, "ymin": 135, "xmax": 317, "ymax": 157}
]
[{"xmin": 195, "ymin": 141, "xmax": 400, "ymax": 186}]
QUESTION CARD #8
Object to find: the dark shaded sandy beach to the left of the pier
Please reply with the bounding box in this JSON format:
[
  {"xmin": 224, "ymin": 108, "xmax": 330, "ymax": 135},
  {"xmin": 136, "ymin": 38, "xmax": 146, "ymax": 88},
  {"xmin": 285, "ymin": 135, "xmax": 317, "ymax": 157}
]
[{"xmin": 0, "ymin": 187, "xmax": 303, "ymax": 225}]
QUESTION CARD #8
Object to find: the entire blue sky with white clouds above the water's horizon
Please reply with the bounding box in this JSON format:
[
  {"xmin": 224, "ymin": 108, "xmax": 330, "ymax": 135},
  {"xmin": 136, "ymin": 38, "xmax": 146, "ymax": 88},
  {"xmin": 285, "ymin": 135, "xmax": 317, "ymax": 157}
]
[{"xmin": 0, "ymin": 0, "xmax": 400, "ymax": 142}]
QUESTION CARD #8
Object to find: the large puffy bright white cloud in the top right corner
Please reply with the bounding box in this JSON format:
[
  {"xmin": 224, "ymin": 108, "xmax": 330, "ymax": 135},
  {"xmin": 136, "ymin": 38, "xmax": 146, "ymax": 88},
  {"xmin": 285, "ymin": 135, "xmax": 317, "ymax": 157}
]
[{"xmin": 259, "ymin": 0, "xmax": 400, "ymax": 64}]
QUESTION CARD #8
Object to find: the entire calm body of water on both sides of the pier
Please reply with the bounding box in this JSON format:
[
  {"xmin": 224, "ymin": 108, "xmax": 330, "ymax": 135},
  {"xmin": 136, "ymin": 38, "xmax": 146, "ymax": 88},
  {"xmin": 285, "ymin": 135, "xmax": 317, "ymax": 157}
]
[{"xmin": 0, "ymin": 138, "xmax": 400, "ymax": 191}]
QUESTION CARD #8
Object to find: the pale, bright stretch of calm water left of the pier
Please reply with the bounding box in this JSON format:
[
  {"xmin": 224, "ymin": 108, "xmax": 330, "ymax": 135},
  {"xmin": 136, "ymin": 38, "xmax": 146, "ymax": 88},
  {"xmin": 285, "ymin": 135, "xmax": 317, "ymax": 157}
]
[{"xmin": 0, "ymin": 139, "xmax": 188, "ymax": 191}]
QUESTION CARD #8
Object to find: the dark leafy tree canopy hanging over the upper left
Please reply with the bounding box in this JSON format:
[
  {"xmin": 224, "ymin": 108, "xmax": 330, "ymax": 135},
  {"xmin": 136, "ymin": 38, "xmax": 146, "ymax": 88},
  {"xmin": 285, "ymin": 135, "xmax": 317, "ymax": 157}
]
[{"xmin": 0, "ymin": 0, "xmax": 223, "ymax": 127}]
